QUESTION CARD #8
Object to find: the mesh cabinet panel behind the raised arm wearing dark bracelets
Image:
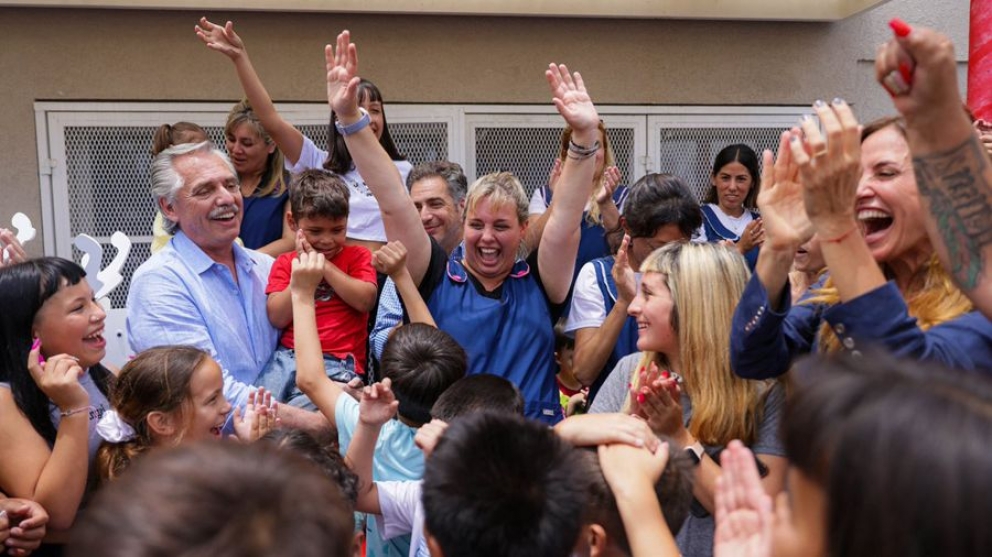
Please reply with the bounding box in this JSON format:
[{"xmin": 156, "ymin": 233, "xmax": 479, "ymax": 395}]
[{"xmin": 475, "ymin": 126, "xmax": 634, "ymax": 196}]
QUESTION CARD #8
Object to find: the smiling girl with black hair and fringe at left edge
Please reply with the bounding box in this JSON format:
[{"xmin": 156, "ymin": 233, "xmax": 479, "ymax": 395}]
[{"xmin": 0, "ymin": 257, "xmax": 113, "ymax": 530}]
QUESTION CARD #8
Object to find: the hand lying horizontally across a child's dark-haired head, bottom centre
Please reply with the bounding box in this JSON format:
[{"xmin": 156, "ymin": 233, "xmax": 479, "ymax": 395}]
[{"xmin": 554, "ymin": 414, "xmax": 660, "ymax": 452}]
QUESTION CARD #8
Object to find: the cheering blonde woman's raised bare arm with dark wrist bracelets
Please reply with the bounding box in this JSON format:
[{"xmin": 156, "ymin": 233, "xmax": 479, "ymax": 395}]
[{"xmin": 537, "ymin": 64, "xmax": 599, "ymax": 303}]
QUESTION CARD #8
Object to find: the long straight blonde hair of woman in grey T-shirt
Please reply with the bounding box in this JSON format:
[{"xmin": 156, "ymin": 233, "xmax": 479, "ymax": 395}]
[{"xmin": 624, "ymin": 242, "xmax": 772, "ymax": 445}]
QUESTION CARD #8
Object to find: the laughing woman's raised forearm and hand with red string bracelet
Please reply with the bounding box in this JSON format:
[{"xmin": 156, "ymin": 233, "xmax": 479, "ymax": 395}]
[{"xmin": 790, "ymin": 99, "xmax": 885, "ymax": 302}]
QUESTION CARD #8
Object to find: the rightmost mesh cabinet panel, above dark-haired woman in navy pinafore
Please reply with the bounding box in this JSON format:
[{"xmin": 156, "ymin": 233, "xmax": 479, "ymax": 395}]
[{"xmin": 658, "ymin": 127, "xmax": 783, "ymax": 202}]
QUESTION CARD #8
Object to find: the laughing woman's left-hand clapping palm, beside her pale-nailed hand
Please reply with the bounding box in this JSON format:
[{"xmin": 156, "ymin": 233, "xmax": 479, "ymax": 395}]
[{"xmin": 758, "ymin": 128, "xmax": 813, "ymax": 252}]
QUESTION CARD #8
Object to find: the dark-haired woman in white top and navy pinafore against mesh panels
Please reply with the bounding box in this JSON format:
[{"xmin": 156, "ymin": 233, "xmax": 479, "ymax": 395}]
[{"xmin": 699, "ymin": 143, "xmax": 764, "ymax": 270}]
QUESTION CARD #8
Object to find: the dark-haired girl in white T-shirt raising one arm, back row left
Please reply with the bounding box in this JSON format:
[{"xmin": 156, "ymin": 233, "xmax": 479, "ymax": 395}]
[{"xmin": 196, "ymin": 18, "xmax": 413, "ymax": 252}]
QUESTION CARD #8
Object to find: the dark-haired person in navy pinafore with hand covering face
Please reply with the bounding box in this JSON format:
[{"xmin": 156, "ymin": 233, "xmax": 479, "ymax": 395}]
[{"xmin": 564, "ymin": 174, "xmax": 702, "ymax": 404}]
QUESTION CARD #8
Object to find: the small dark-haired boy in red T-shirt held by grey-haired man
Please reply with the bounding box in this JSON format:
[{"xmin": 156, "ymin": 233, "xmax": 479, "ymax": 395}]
[{"xmin": 255, "ymin": 169, "xmax": 376, "ymax": 409}]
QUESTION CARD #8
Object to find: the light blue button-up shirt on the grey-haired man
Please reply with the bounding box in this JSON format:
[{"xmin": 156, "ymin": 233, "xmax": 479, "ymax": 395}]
[{"xmin": 127, "ymin": 231, "xmax": 279, "ymax": 407}]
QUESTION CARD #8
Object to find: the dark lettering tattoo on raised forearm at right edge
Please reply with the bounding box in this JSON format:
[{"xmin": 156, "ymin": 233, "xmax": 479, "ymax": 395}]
[{"xmin": 913, "ymin": 134, "xmax": 992, "ymax": 290}]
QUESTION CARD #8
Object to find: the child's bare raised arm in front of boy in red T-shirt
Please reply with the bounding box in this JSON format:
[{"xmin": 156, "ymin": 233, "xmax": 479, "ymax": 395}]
[{"xmin": 289, "ymin": 252, "xmax": 344, "ymax": 426}]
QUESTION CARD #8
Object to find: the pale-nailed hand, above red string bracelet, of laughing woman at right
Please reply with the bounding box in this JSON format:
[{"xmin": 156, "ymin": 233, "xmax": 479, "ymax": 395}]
[{"xmin": 789, "ymin": 99, "xmax": 861, "ymax": 242}]
